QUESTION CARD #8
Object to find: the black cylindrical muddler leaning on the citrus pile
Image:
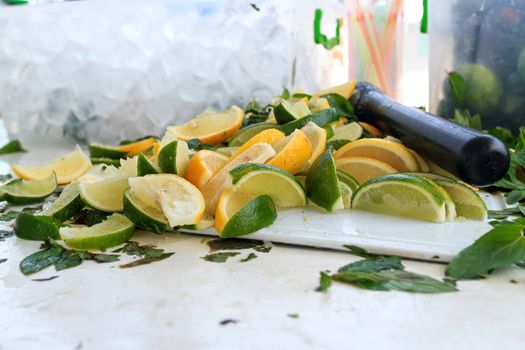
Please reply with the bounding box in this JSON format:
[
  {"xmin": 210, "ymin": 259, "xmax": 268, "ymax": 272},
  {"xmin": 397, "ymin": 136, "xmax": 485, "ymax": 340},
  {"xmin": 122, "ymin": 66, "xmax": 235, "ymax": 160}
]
[{"xmin": 350, "ymin": 82, "xmax": 509, "ymax": 186}]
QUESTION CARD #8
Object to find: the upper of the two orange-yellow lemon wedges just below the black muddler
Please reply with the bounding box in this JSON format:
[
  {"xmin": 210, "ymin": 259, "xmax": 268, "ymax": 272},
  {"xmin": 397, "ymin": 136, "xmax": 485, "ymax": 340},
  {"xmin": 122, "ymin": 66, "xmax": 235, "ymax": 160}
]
[{"xmin": 334, "ymin": 138, "xmax": 418, "ymax": 172}]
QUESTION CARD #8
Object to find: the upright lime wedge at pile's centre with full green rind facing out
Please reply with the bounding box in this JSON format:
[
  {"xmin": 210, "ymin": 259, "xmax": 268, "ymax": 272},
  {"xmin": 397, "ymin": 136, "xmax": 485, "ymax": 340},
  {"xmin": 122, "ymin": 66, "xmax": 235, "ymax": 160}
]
[{"xmin": 306, "ymin": 150, "xmax": 344, "ymax": 211}]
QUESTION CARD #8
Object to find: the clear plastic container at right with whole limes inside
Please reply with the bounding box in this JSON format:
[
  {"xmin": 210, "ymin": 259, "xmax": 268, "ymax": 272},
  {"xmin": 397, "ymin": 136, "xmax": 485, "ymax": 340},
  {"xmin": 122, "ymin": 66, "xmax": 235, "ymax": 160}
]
[{"xmin": 429, "ymin": 0, "xmax": 525, "ymax": 131}]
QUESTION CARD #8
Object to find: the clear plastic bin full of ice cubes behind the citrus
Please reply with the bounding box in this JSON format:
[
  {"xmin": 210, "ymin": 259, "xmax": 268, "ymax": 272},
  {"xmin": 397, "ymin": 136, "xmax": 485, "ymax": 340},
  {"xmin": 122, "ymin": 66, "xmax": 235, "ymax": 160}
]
[{"xmin": 0, "ymin": 0, "xmax": 348, "ymax": 145}]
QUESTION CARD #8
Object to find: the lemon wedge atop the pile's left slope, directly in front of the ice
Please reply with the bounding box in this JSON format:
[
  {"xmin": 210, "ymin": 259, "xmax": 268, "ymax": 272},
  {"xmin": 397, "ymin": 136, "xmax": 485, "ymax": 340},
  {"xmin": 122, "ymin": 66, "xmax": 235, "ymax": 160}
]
[{"xmin": 167, "ymin": 106, "xmax": 244, "ymax": 145}]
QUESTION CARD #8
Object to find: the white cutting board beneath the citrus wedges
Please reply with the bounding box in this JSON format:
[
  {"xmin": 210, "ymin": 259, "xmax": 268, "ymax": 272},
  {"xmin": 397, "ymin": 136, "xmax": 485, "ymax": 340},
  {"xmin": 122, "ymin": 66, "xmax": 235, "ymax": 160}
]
[{"xmin": 0, "ymin": 148, "xmax": 505, "ymax": 262}]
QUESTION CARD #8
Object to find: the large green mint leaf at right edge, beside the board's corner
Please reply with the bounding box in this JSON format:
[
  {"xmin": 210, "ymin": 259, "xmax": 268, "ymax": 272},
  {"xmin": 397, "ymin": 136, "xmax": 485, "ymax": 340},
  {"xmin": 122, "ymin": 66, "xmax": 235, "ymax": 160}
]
[{"xmin": 445, "ymin": 218, "xmax": 525, "ymax": 279}]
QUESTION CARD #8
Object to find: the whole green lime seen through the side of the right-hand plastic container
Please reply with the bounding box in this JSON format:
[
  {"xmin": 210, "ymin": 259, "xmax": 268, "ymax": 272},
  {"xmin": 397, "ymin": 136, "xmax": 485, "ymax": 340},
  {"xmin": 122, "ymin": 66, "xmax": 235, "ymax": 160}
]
[{"xmin": 458, "ymin": 63, "xmax": 502, "ymax": 115}]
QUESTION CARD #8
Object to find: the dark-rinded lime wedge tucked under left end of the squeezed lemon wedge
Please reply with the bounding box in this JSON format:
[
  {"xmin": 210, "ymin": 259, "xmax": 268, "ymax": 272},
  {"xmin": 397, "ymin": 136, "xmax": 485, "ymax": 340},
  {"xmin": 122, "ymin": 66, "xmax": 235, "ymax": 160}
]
[{"xmin": 124, "ymin": 190, "xmax": 168, "ymax": 234}]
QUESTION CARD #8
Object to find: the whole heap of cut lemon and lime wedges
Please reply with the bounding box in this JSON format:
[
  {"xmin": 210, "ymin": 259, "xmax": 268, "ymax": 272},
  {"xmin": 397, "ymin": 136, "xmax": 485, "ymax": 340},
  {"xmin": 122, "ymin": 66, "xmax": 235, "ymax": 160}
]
[{"xmin": 6, "ymin": 81, "xmax": 487, "ymax": 249}]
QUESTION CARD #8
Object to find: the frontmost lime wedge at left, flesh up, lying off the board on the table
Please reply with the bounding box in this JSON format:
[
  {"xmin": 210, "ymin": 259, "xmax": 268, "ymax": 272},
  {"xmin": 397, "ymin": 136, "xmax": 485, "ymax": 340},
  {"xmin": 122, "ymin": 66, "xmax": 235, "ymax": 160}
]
[{"xmin": 60, "ymin": 214, "xmax": 135, "ymax": 250}]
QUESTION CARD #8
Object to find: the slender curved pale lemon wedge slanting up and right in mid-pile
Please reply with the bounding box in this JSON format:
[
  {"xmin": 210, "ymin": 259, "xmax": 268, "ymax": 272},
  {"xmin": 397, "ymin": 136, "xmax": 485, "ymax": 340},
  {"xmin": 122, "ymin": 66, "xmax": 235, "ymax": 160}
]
[{"xmin": 201, "ymin": 142, "xmax": 275, "ymax": 216}]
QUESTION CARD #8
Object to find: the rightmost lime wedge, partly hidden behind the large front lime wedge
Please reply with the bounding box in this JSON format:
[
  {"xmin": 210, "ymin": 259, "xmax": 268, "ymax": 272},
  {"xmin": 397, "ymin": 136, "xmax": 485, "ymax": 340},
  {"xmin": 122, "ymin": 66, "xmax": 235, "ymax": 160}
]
[{"xmin": 417, "ymin": 173, "xmax": 487, "ymax": 220}]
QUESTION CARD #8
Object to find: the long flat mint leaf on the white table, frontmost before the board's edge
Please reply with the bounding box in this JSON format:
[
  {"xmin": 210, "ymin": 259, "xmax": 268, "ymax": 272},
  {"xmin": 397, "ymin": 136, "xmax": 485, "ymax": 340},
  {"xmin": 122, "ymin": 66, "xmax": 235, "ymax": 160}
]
[{"xmin": 332, "ymin": 270, "xmax": 457, "ymax": 293}]
